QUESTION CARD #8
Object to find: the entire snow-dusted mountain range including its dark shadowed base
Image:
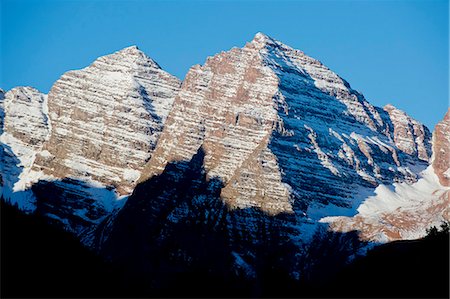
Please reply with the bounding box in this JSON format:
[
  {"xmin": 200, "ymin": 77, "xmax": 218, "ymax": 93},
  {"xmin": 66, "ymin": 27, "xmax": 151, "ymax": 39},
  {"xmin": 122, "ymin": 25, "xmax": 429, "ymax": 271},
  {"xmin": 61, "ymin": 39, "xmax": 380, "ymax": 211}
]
[{"xmin": 0, "ymin": 33, "xmax": 449, "ymax": 286}]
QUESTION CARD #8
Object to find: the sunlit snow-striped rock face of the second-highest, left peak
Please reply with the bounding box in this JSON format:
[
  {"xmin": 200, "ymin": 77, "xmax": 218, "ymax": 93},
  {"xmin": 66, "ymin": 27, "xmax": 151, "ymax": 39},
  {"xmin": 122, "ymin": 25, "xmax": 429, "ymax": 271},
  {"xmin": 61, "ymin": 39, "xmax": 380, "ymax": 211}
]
[{"xmin": 36, "ymin": 47, "xmax": 180, "ymax": 195}]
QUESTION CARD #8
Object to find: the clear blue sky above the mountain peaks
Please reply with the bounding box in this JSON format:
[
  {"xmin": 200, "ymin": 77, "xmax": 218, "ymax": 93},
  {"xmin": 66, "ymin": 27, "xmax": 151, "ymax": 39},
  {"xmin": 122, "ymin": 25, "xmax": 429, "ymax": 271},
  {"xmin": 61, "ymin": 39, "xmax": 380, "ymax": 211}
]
[{"xmin": 0, "ymin": 0, "xmax": 449, "ymax": 128}]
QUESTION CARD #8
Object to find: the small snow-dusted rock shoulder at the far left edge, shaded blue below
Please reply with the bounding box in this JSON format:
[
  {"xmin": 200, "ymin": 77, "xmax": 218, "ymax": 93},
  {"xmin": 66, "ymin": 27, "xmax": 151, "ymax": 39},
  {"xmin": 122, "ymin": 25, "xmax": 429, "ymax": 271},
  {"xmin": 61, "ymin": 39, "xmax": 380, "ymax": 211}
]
[{"xmin": 0, "ymin": 87, "xmax": 50, "ymax": 212}]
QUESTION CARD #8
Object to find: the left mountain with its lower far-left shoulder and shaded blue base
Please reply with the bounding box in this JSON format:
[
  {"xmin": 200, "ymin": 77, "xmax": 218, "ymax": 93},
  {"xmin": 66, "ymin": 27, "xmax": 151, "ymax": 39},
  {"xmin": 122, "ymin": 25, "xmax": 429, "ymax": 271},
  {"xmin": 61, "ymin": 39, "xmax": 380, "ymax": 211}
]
[{"xmin": 2, "ymin": 46, "xmax": 181, "ymax": 243}]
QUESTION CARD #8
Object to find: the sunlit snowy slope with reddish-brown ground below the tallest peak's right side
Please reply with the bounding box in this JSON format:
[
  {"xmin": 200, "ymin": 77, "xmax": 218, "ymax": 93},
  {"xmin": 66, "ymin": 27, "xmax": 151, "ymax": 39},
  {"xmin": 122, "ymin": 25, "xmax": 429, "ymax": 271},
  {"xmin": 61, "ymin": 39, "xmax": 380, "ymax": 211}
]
[{"xmin": 321, "ymin": 166, "xmax": 450, "ymax": 243}]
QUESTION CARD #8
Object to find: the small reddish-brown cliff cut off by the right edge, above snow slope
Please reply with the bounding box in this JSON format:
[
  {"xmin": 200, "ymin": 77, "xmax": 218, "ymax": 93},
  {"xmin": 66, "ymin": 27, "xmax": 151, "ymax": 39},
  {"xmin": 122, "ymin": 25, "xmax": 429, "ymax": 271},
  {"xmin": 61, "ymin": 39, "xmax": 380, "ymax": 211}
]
[{"xmin": 433, "ymin": 109, "xmax": 450, "ymax": 187}]
